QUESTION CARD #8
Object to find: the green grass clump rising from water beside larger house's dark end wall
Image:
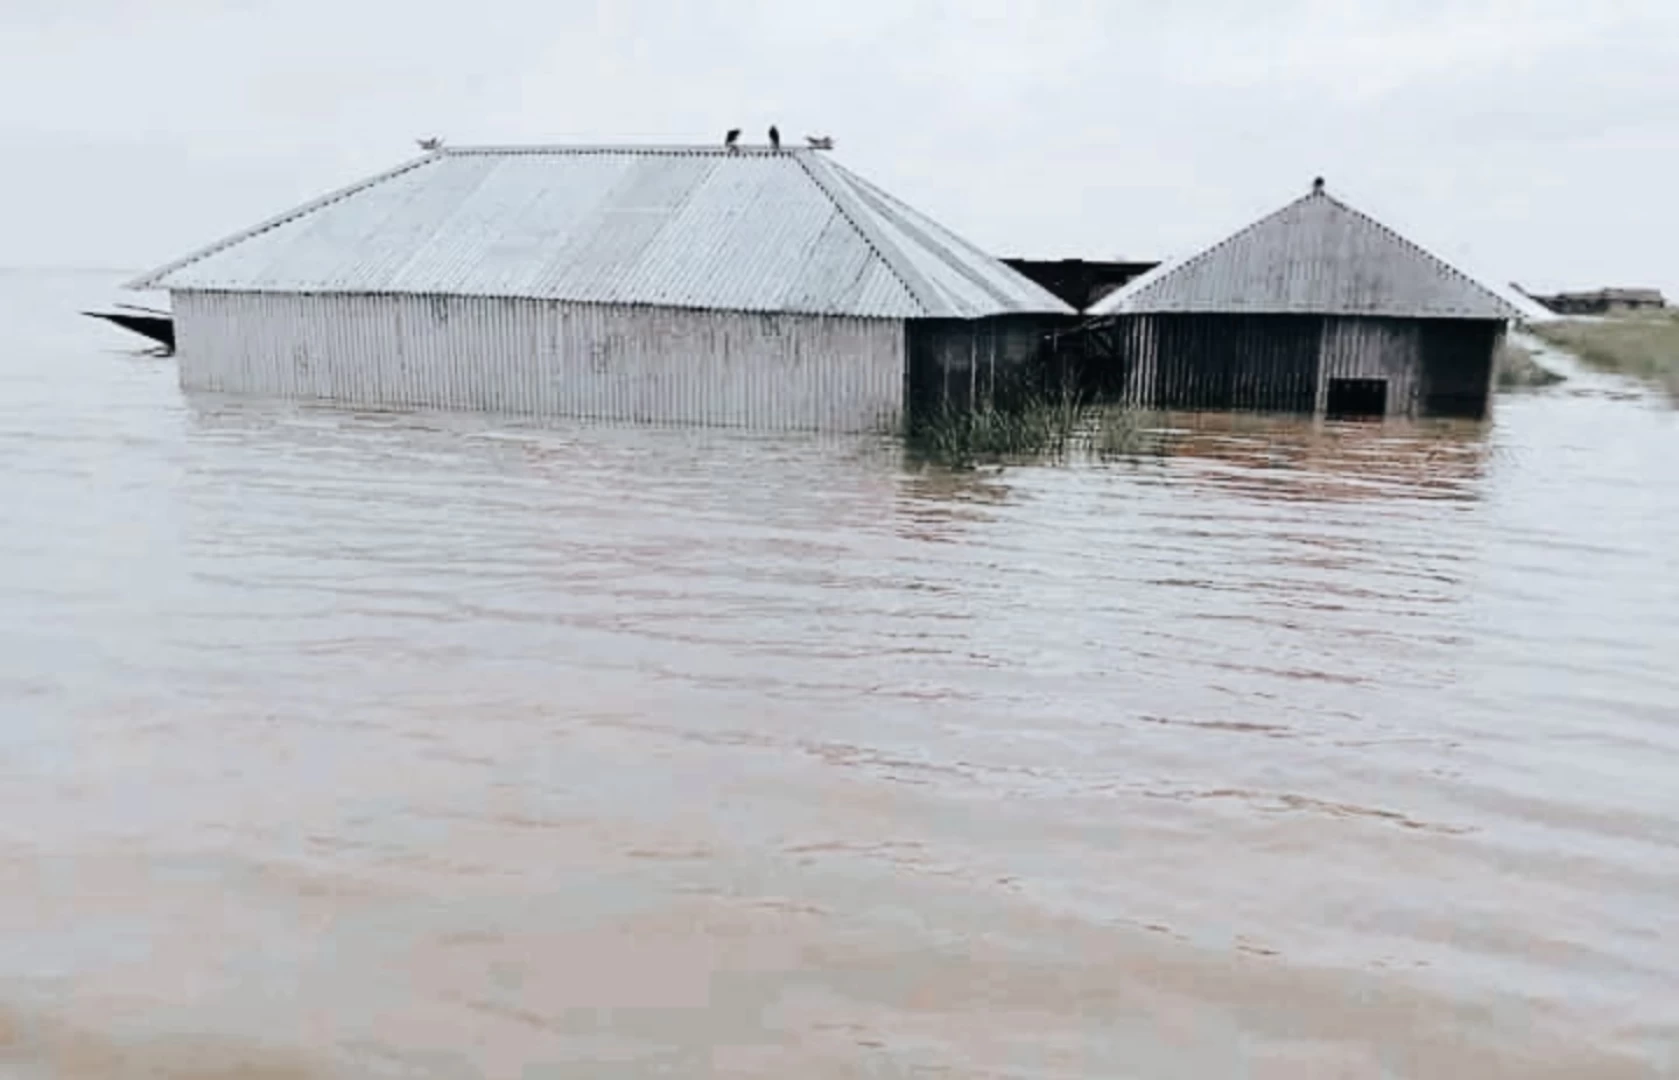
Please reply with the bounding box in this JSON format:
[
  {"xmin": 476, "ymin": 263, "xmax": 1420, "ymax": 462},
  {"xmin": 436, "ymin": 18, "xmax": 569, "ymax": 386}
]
[{"xmin": 908, "ymin": 395, "xmax": 1150, "ymax": 467}]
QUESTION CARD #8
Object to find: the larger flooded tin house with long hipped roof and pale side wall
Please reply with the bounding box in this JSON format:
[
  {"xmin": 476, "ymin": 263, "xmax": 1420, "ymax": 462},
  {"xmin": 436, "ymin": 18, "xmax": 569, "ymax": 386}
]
[{"xmin": 129, "ymin": 146, "xmax": 1075, "ymax": 432}]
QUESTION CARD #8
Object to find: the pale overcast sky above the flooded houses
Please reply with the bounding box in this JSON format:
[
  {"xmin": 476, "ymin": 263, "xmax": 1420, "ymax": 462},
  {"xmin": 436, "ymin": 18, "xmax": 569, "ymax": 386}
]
[{"xmin": 0, "ymin": 0, "xmax": 1679, "ymax": 294}]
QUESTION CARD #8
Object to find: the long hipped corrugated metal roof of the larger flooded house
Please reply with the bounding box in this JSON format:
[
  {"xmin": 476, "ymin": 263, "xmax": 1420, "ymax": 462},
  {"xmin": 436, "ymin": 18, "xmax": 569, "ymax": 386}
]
[{"xmin": 129, "ymin": 146, "xmax": 1071, "ymax": 317}]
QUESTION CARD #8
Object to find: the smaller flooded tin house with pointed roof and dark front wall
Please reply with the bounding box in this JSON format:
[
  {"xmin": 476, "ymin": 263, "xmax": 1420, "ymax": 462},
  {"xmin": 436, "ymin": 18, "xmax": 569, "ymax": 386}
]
[{"xmin": 1088, "ymin": 180, "xmax": 1523, "ymax": 418}]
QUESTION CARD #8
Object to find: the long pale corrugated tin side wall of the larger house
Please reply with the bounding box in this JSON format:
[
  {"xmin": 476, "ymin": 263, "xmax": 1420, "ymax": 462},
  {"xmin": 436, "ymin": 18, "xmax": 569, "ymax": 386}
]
[{"xmin": 173, "ymin": 292, "xmax": 905, "ymax": 432}]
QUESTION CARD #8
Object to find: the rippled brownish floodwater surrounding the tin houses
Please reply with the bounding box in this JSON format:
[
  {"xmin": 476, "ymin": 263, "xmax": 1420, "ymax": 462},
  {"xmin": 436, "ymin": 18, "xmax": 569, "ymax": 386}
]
[{"xmin": 0, "ymin": 274, "xmax": 1679, "ymax": 1078}]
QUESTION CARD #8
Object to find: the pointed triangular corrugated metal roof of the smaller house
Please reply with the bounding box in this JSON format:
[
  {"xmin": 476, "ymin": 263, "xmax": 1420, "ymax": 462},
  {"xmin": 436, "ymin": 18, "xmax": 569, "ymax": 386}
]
[{"xmin": 1090, "ymin": 190, "xmax": 1523, "ymax": 319}]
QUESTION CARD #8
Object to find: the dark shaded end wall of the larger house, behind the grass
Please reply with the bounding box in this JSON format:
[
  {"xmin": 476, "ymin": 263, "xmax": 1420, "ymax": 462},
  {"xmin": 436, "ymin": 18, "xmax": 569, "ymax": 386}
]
[{"xmin": 903, "ymin": 316, "xmax": 1073, "ymax": 417}]
